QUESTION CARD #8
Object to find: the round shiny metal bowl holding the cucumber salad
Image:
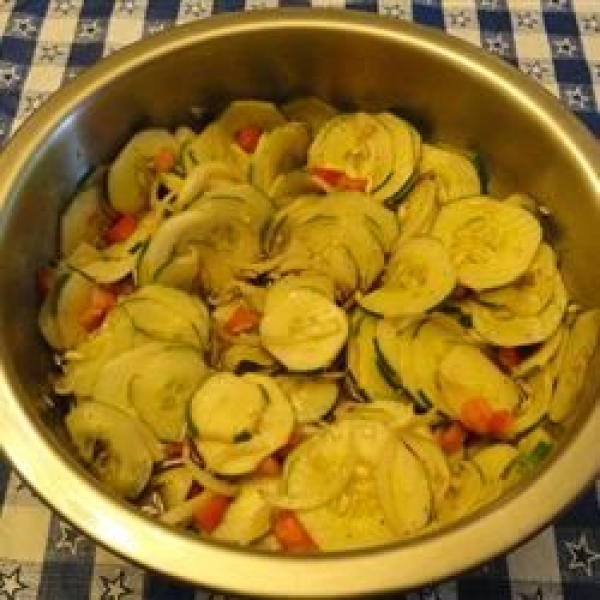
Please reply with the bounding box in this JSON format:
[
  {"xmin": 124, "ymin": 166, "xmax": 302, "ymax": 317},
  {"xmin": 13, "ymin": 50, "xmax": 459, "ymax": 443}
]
[{"xmin": 0, "ymin": 10, "xmax": 600, "ymax": 598}]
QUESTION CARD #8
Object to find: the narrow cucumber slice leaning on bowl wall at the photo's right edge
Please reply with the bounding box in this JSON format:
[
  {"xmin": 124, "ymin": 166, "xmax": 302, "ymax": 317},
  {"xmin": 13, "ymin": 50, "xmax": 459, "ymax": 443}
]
[{"xmin": 548, "ymin": 310, "xmax": 600, "ymax": 423}]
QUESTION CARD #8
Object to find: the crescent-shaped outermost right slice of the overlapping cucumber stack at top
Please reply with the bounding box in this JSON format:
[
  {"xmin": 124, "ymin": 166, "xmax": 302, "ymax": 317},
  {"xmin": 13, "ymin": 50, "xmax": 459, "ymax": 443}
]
[{"xmin": 372, "ymin": 112, "xmax": 421, "ymax": 204}]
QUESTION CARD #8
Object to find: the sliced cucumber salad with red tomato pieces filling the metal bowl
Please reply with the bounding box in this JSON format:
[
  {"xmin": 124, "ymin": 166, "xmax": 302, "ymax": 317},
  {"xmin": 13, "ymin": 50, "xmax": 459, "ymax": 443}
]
[{"xmin": 38, "ymin": 97, "xmax": 600, "ymax": 552}]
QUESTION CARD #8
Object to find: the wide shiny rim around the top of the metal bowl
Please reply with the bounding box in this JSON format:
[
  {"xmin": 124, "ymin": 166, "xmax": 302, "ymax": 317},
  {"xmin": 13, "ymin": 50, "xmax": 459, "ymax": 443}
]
[{"xmin": 0, "ymin": 9, "xmax": 600, "ymax": 598}]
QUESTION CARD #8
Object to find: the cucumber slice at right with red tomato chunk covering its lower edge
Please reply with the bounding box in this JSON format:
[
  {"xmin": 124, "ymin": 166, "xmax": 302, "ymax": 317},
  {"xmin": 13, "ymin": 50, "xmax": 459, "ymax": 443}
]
[{"xmin": 438, "ymin": 344, "xmax": 520, "ymax": 417}]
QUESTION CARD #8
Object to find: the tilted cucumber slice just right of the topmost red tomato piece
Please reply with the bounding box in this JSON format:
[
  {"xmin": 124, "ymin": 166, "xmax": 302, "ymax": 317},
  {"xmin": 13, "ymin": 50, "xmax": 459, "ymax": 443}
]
[{"xmin": 250, "ymin": 123, "xmax": 310, "ymax": 193}]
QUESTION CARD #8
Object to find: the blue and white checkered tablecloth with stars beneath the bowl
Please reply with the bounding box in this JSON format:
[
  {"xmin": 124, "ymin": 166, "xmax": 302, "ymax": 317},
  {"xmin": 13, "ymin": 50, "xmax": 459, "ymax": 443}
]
[{"xmin": 0, "ymin": 0, "xmax": 600, "ymax": 600}]
